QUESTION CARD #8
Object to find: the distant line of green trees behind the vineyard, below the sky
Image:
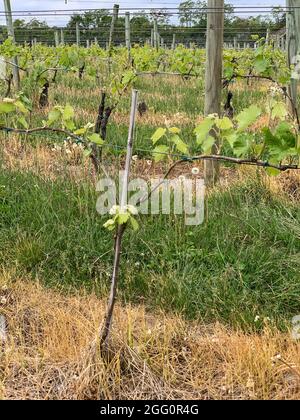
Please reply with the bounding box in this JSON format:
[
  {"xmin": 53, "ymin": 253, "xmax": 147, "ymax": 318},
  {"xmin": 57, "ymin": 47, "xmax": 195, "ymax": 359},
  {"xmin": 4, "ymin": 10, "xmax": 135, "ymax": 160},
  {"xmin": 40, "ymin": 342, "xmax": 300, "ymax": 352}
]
[{"xmin": 0, "ymin": 0, "xmax": 286, "ymax": 46}]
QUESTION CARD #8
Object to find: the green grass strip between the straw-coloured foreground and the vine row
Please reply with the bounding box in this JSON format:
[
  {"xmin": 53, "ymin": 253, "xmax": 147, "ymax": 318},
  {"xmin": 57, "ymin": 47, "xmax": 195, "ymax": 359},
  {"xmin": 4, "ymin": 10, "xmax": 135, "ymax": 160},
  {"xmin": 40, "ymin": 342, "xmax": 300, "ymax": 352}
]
[{"xmin": 0, "ymin": 162, "xmax": 300, "ymax": 330}]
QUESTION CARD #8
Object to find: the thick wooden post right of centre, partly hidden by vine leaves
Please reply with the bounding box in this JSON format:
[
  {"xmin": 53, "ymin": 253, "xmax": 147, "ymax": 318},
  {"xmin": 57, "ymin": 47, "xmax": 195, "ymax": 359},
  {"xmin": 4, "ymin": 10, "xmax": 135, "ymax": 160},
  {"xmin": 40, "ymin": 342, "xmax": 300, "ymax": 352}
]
[{"xmin": 204, "ymin": 0, "xmax": 224, "ymax": 186}]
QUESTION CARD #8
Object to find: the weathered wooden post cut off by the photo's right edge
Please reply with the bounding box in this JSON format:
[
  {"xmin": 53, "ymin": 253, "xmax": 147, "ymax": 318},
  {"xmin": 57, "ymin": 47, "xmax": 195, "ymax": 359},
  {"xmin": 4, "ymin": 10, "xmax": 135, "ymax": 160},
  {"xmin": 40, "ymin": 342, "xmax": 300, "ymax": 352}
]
[{"xmin": 286, "ymin": 0, "xmax": 300, "ymax": 116}]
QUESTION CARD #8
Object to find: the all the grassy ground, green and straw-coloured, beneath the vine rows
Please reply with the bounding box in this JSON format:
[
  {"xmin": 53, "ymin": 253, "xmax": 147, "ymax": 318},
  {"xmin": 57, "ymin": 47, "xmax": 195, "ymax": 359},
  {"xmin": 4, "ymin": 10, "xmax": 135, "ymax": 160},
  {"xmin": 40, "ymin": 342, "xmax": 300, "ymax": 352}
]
[{"xmin": 0, "ymin": 63, "xmax": 300, "ymax": 399}]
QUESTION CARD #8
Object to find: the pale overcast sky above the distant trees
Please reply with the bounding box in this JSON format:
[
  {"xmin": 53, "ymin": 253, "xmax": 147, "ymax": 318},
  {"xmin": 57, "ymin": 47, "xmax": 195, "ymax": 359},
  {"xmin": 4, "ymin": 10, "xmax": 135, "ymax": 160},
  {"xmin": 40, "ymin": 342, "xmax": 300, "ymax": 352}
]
[{"xmin": 0, "ymin": 0, "xmax": 285, "ymax": 25}]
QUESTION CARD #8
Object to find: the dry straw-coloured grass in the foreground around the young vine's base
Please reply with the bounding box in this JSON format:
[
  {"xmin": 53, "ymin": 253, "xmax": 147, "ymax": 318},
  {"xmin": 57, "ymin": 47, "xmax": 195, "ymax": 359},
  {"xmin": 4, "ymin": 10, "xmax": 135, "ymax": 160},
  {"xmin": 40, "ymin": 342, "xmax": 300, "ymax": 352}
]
[{"xmin": 0, "ymin": 274, "xmax": 300, "ymax": 400}]
